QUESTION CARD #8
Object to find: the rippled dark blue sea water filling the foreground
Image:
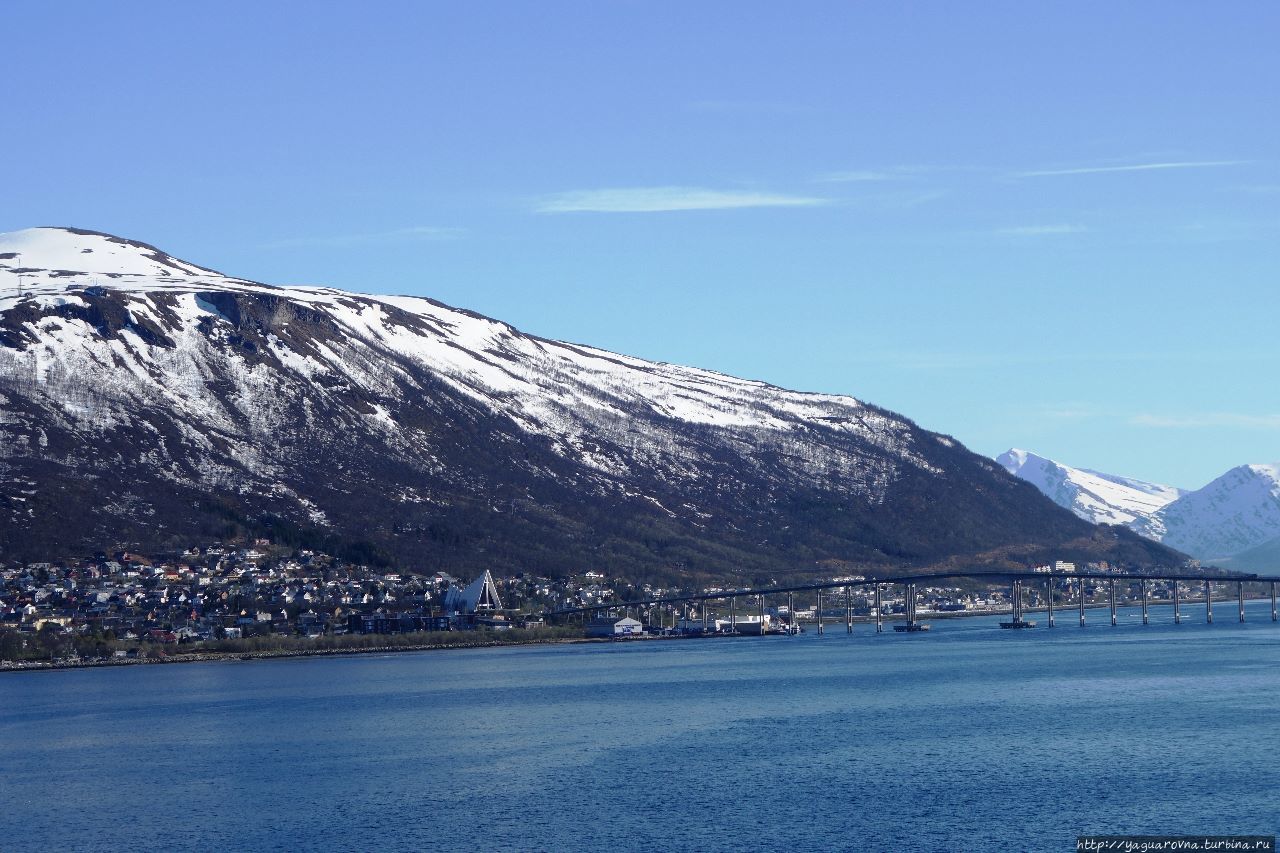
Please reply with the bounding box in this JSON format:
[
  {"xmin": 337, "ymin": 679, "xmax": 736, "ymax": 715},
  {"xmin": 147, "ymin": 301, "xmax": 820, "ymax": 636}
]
[{"xmin": 0, "ymin": 602, "xmax": 1280, "ymax": 850}]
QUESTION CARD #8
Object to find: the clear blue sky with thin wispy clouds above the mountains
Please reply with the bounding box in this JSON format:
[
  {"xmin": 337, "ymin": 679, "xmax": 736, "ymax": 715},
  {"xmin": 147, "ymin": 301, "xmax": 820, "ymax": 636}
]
[{"xmin": 0, "ymin": 0, "xmax": 1280, "ymax": 488}]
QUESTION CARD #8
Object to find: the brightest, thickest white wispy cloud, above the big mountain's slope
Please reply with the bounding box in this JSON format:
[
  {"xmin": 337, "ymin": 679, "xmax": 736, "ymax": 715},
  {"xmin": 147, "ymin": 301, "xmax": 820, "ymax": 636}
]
[{"xmin": 534, "ymin": 187, "xmax": 829, "ymax": 214}]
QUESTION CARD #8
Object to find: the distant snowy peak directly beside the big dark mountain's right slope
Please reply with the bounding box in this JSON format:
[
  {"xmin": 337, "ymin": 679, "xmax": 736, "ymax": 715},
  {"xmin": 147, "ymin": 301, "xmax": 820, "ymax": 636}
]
[{"xmin": 996, "ymin": 447, "xmax": 1185, "ymax": 525}]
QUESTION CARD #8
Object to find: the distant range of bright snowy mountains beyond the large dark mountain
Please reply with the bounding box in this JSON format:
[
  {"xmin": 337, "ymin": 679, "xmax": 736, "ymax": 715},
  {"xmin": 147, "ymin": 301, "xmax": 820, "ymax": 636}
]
[{"xmin": 996, "ymin": 448, "xmax": 1280, "ymax": 569}]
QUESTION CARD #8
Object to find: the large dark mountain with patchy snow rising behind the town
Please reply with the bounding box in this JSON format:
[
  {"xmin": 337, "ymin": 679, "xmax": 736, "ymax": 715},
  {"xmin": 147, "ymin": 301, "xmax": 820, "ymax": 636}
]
[{"xmin": 0, "ymin": 228, "xmax": 1176, "ymax": 576}]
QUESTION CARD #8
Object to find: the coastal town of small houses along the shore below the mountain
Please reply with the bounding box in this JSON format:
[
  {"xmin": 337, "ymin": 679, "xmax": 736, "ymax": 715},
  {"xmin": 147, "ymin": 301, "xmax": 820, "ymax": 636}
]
[{"xmin": 0, "ymin": 539, "xmax": 1208, "ymax": 667}]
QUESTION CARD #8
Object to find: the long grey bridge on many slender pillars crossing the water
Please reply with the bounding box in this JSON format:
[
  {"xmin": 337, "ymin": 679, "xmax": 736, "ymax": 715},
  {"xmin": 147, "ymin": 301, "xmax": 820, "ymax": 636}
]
[{"xmin": 543, "ymin": 570, "xmax": 1280, "ymax": 634}]
